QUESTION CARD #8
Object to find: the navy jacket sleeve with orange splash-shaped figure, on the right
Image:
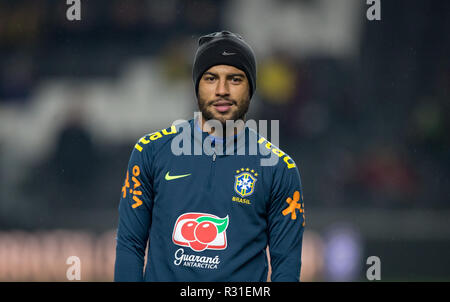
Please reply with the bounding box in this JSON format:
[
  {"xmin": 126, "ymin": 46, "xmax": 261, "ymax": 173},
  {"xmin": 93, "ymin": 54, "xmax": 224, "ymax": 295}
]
[{"xmin": 268, "ymin": 162, "xmax": 305, "ymax": 282}]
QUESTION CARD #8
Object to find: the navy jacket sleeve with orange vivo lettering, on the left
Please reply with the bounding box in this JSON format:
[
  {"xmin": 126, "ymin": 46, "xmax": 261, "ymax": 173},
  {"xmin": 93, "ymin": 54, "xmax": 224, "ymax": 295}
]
[{"xmin": 114, "ymin": 139, "xmax": 153, "ymax": 282}]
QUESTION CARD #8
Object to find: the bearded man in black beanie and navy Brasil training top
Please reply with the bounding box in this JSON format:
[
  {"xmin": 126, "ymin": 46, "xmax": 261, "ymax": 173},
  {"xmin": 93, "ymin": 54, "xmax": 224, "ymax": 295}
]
[{"xmin": 114, "ymin": 31, "xmax": 305, "ymax": 282}]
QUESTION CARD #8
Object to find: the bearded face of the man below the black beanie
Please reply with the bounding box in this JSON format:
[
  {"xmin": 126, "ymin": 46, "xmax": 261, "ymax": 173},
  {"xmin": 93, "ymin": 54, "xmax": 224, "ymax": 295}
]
[{"xmin": 198, "ymin": 65, "xmax": 250, "ymax": 125}]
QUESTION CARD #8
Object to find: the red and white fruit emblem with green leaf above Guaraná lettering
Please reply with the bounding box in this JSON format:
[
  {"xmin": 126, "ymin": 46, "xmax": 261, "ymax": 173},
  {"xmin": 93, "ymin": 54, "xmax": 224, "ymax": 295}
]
[{"xmin": 172, "ymin": 213, "xmax": 228, "ymax": 252}]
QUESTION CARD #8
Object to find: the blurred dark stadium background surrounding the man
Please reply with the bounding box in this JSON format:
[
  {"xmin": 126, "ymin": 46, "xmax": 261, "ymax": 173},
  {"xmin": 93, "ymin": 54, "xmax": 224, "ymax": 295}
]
[{"xmin": 0, "ymin": 0, "xmax": 450, "ymax": 281}]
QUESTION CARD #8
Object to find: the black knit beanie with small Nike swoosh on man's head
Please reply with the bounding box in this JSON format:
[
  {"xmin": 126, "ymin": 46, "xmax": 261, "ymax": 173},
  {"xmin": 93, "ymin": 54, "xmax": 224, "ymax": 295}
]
[{"xmin": 192, "ymin": 31, "xmax": 256, "ymax": 98}]
